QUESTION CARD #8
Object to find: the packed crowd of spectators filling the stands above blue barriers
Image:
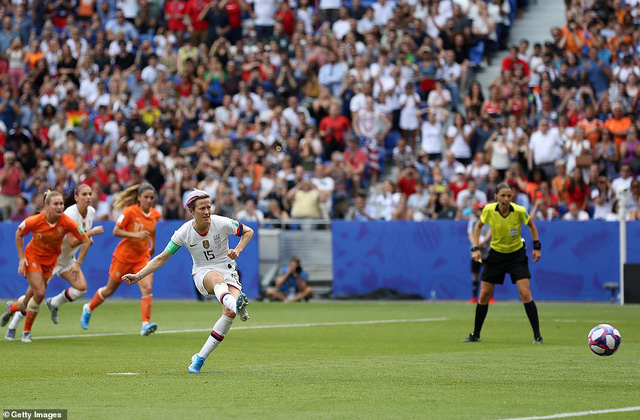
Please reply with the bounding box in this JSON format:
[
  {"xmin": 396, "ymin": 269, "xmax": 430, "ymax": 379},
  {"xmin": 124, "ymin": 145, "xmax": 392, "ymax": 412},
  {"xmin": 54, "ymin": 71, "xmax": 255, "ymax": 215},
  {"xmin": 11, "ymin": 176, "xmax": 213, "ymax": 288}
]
[{"xmin": 0, "ymin": 0, "xmax": 640, "ymax": 226}]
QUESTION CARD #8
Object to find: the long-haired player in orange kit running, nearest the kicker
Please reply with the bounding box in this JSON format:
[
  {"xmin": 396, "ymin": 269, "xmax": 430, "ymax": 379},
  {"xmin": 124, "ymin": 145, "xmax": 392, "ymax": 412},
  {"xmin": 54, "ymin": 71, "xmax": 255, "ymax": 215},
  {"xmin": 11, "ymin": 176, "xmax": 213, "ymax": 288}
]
[{"xmin": 80, "ymin": 183, "xmax": 160, "ymax": 336}]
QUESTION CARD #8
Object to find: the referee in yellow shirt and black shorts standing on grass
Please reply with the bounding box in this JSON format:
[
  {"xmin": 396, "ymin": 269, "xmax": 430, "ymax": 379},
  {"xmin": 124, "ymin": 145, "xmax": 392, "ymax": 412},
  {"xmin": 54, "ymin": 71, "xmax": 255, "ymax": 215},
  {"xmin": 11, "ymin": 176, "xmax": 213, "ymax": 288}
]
[{"xmin": 463, "ymin": 183, "xmax": 542, "ymax": 344}]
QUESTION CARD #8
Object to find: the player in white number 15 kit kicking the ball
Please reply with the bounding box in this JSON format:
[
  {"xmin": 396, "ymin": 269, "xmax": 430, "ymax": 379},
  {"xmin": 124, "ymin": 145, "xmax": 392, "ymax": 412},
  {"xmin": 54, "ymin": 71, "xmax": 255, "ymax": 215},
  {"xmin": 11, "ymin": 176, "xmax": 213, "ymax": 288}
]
[{"xmin": 122, "ymin": 189, "xmax": 253, "ymax": 373}]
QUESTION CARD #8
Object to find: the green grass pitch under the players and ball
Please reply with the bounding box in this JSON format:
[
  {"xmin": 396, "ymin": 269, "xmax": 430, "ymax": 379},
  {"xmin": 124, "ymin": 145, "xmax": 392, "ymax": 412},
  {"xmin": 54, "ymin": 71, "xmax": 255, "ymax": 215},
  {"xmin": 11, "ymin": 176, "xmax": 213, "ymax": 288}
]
[{"xmin": 0, "ymin": 300, "xmax": 640, "ymax": 419}]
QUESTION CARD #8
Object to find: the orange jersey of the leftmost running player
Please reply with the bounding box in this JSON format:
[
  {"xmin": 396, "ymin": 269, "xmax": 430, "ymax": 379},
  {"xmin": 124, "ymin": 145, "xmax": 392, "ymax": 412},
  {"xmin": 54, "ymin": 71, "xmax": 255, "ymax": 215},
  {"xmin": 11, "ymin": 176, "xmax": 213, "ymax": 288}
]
[{"xmin": 18, "ymin": 213, "xmax": 85, "ymax": 266}]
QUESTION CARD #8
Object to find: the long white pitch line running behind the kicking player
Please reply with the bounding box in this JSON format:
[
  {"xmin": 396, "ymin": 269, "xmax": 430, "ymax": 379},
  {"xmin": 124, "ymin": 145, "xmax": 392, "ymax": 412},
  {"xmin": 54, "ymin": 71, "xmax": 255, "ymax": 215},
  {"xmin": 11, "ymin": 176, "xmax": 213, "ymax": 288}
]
[{"xmin": 27, "ymin": 318, "xmax": 447, "ymax": 340}]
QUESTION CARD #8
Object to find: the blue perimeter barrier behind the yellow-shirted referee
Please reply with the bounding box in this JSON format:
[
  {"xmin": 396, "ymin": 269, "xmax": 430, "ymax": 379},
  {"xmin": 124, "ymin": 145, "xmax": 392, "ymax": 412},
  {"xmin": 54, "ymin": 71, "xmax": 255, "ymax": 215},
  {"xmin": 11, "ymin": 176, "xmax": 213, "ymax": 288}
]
[{"xmin": 332, "ymin": 221, "xmax": 628, "ymax": 302}]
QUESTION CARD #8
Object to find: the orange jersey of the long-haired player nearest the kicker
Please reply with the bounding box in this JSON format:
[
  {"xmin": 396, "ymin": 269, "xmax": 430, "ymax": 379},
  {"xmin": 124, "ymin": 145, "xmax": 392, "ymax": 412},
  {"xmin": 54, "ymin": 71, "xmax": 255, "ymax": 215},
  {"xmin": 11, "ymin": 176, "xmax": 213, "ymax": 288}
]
[{"xmin": 113, "ymin": 204, "xmax": 160, "ymax": 263}]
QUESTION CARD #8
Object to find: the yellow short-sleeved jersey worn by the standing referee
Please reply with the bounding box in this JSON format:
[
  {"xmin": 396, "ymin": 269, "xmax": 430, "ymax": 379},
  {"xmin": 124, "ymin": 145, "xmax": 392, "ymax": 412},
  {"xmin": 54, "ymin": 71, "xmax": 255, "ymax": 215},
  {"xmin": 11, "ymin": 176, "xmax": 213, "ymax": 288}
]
[{"xmin": 480, "ymin": 203, "xmax": 529, "ymax": 254}]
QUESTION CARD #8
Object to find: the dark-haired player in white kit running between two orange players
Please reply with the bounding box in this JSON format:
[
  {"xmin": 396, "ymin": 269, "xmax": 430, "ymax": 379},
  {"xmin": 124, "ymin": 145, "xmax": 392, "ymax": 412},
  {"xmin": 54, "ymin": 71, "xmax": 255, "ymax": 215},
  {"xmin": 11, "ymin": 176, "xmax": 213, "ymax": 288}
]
[{"xmin": 5, "ymin": 184, "xmax": 104, "ymax": 340}]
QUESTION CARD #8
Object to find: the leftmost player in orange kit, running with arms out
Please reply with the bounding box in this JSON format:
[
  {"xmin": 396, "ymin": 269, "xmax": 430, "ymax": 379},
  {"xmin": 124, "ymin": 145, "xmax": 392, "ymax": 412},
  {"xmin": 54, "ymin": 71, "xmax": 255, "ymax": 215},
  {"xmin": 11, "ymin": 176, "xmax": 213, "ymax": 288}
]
[{"xmin": 11, "ymin": 191, "xmax": 91, "ymax": 343}]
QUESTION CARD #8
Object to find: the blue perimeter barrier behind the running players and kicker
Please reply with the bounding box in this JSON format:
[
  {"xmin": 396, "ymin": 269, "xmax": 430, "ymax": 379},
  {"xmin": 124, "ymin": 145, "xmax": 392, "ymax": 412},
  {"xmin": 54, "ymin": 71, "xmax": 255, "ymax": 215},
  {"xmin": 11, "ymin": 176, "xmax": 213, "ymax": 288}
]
[{"xmin": 0, "ymin": 221, "xmax": 260, "ymax": 299}]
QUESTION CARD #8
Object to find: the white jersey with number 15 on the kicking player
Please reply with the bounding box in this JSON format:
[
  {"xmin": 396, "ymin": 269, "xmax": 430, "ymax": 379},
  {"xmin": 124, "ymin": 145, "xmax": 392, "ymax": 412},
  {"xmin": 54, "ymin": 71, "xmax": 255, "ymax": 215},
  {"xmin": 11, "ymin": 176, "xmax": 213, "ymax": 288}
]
[{"xmin": 166, "ymin": 215, "xmax": 242, "ymax": 274}]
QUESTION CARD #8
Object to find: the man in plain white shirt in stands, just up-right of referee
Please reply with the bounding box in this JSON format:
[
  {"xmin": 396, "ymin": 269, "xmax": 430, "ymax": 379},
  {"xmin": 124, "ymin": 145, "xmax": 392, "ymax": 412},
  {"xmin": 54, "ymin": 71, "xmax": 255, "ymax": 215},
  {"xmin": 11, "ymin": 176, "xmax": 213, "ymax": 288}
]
[{"xmin": 527, "ymin": 119, "xmax": 562, "ymax": 179}]
